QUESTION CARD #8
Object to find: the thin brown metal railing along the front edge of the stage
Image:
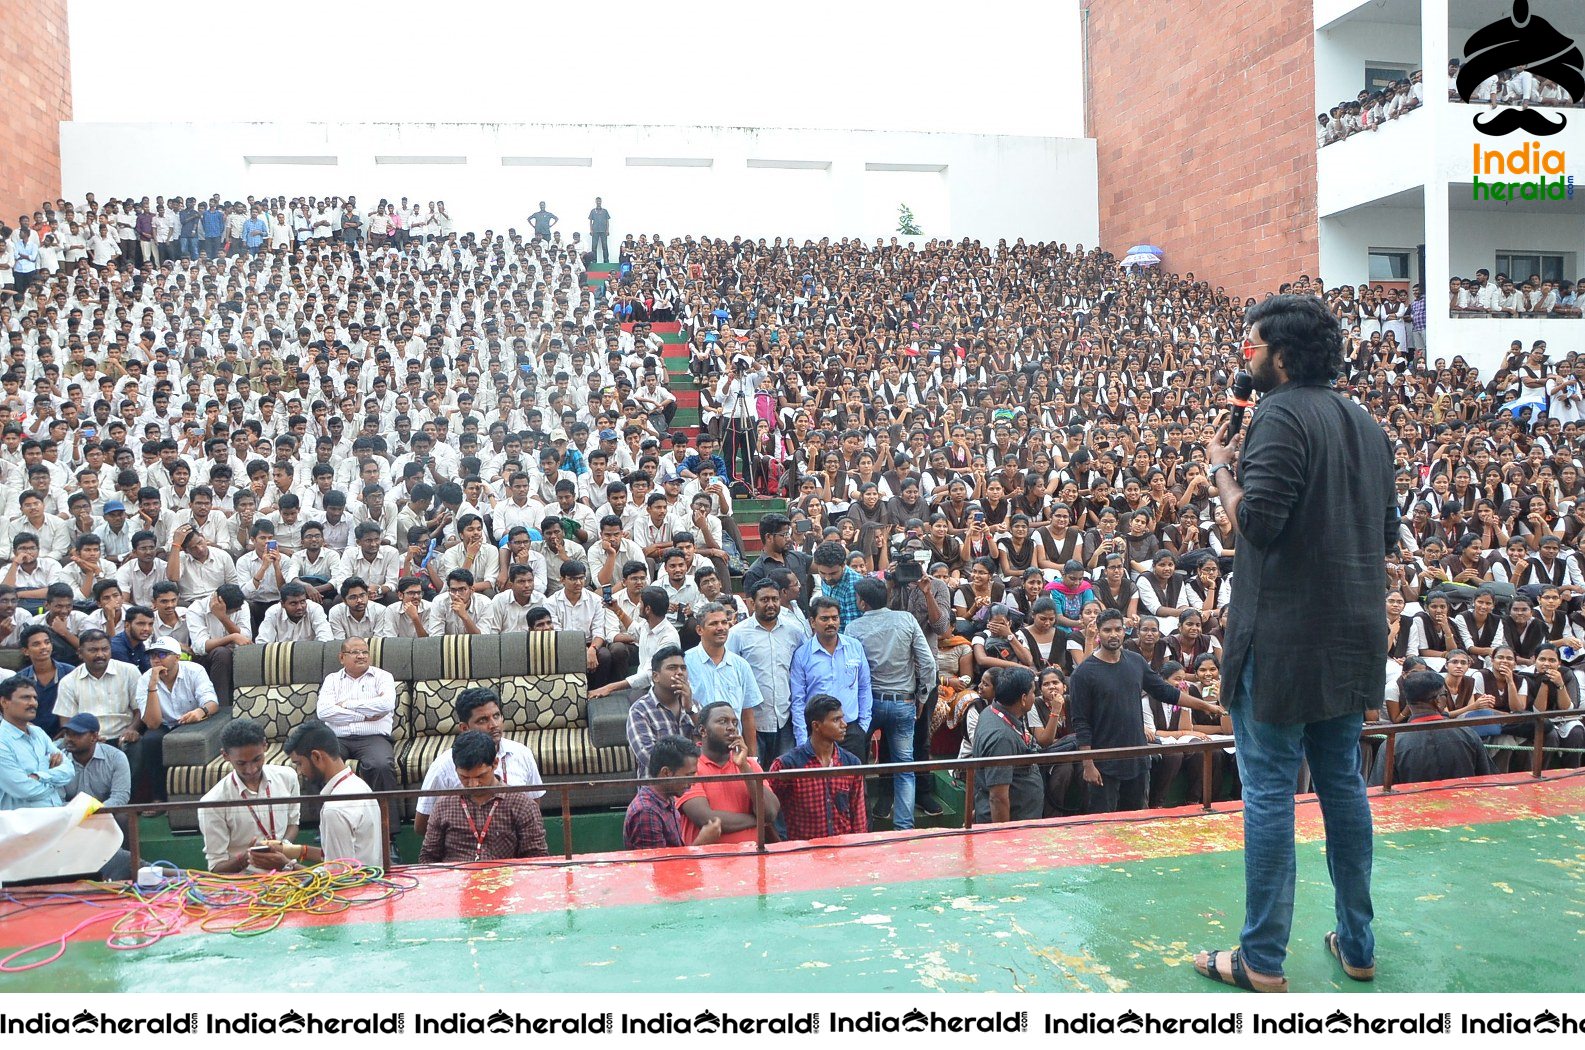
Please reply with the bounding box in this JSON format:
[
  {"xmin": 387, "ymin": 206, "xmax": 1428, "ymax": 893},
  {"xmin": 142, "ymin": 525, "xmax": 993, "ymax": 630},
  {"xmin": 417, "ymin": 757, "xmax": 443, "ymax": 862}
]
[{"xmin": 98, "ymin": 711, "xmax": 1585, "ymax": 871}]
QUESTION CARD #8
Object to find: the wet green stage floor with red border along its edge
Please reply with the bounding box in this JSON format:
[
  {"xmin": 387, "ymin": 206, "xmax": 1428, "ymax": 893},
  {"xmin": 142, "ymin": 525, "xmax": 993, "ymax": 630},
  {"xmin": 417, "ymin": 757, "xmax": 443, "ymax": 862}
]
[{"xmin": 0, "ymin": 772, "xmax": 1585, "ymax": 993}]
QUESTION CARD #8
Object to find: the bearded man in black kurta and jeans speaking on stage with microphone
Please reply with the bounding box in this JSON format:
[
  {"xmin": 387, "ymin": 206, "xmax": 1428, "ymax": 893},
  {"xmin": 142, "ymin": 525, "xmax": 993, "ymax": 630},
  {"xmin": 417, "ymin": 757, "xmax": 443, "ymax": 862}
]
[{"xmin": 1195, "ymin": 295, "xmax": 1398, "ymax": 991}]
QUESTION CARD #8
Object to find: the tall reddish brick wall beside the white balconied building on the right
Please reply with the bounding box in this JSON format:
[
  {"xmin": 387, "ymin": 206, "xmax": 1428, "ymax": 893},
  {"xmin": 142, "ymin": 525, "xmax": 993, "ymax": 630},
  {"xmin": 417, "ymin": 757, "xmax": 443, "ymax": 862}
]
[{"xmin": 1084, "ymin": 0, "xmax": 1325, "ymax": 295}]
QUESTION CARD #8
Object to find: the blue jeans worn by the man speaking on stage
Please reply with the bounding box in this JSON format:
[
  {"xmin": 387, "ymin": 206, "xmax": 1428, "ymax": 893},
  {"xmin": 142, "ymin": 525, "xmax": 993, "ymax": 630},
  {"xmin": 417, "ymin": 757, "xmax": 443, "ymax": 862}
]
[{"xmin": 1228, "ymin": 653, "xmax": 1376, "ymax": 975}]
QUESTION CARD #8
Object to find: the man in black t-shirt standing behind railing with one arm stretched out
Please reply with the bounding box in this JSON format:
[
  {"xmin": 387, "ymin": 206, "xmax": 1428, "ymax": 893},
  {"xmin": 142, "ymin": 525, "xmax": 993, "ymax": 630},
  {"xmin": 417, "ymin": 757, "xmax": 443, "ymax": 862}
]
[{"xmin": 1068, "ymin": 609, "xmax": 1222, "ymax": 814}]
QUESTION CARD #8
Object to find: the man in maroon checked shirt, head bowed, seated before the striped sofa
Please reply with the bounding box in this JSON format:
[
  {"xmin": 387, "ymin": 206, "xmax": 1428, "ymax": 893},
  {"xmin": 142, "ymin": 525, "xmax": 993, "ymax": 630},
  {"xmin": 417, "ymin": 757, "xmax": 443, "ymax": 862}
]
[{"xmin": 418, "ymin": 730, "xmax": 545, "ymax": 864}]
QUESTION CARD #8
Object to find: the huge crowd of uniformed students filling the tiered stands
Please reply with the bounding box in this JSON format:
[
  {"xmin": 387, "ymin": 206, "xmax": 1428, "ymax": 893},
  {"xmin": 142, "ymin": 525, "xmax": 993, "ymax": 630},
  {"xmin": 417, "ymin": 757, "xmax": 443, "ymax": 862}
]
[{"xmin": 0, "ymin": 187, "xmax": 1585, "ymax": 860}]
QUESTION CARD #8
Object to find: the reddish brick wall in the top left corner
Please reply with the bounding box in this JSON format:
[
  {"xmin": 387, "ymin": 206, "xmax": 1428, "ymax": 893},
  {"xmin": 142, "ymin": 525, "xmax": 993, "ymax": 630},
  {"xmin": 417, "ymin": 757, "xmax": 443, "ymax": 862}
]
[{"xmin": 0, "ymin": 0, "xmax": 71, "ymax": 225}]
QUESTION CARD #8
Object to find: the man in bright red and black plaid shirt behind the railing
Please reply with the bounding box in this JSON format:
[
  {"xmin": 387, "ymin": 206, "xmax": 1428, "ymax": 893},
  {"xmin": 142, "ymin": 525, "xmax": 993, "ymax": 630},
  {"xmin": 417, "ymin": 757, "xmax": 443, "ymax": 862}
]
[{"xmin": 770, "ymin": 693, "xmax": 869, "ymax": 839}]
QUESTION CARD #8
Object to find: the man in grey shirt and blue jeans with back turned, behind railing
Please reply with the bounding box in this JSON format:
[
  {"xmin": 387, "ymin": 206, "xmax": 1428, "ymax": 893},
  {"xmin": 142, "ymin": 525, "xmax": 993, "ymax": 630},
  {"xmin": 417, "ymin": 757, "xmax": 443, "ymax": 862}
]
[{"xmin": 846, "ymin": 576, "xmax": 935, "ymax": 831}]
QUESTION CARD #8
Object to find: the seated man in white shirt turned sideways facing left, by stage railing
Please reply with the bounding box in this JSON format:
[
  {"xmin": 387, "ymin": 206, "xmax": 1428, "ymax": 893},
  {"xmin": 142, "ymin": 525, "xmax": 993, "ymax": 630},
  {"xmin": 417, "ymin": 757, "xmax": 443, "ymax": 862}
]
[{"xmin": 271, "ymin": 720, "xmax": 382, "ymax": 868}]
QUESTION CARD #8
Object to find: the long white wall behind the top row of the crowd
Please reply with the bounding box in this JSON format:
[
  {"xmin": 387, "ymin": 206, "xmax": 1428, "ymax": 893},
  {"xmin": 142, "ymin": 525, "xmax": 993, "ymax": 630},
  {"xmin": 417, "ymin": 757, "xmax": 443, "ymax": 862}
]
[{"xmin": 60, "ymin": 122, "xmax": 1100, "ymax": 244}]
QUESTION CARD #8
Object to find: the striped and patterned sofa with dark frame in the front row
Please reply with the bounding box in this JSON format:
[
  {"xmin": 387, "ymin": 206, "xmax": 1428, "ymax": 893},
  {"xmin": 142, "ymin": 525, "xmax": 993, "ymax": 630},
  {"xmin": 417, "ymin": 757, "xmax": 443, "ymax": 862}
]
[{"xmin": 165, "ymin": 631, "xmax": 632, "ymax": 830}]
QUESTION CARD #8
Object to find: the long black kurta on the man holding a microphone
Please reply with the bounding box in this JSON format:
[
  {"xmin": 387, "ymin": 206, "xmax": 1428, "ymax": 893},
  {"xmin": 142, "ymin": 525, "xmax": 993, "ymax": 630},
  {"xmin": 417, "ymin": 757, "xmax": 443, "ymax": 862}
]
[{"xmin": 1222, "ymin": 382, "xmax": 1398, "ymax": 725}]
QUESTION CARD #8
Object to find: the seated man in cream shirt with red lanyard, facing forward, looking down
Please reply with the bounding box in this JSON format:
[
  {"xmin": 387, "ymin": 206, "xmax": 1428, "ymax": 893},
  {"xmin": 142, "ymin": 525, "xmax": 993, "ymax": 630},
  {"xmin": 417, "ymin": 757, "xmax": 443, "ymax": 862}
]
[{"xmin": 198, "ymin": 719, "xmax": 301, "ymax": 874}]
